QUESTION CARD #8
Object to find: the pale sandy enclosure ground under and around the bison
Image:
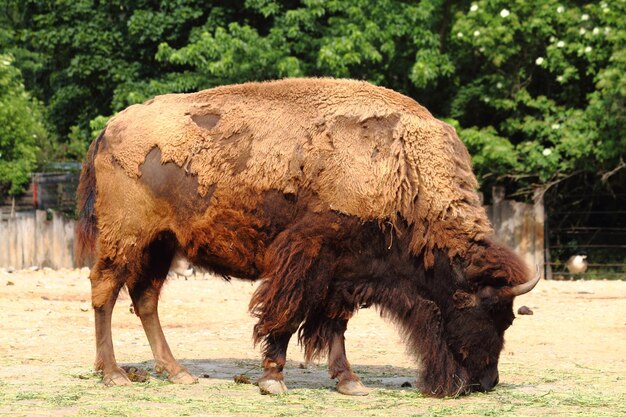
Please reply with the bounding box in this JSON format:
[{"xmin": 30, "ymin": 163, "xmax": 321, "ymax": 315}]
[{"xmin": 0, "ymin": 270, "xmax": 626, "ymax": 417}]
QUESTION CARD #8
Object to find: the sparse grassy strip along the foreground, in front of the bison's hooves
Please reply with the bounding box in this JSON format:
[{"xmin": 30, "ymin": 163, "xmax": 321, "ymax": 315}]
[{"xmin": 0, "ymin": 360, "xmax": 626, "ymax": 417}]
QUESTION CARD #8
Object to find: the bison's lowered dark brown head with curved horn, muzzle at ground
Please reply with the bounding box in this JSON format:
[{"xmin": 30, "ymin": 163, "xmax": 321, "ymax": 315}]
[{"xmin": 414, "ymin": 241, "xmax": 539, "ymax": 396}]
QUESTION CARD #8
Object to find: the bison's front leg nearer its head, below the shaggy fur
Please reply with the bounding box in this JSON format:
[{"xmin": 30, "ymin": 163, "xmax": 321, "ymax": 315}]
[{"xmin": 328, "ymin": 319, "xmax": 369, "ymax": 395}]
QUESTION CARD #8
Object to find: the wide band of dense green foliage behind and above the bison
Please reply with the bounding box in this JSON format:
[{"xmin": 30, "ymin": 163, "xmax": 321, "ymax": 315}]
[{"xmin": 0, "ymin": 0, "xmax": 626, "ymax": 197}]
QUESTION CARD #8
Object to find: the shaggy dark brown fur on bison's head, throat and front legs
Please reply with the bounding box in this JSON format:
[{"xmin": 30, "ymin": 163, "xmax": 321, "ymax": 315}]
[{"xmin": 250, "ymin": 214, "xmax": 527, "ymax": 396}]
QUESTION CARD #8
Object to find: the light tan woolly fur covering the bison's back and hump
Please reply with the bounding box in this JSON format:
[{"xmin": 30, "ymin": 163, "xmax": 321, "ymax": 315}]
[{"xmin": 101, "ymin": 79, "xmax": 491, "ymax": 268}]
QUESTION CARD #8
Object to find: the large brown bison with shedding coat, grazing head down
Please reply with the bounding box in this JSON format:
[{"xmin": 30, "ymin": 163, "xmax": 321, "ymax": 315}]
[{"xmin": 77, "ymin": 79, "xmax": 539, "ymax": 396}]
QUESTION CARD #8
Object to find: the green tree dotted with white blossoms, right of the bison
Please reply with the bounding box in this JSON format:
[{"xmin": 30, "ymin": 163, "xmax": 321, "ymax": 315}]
[{"xmin": 450, "ymin": 0, "xmax": 626, "ymax": 193}]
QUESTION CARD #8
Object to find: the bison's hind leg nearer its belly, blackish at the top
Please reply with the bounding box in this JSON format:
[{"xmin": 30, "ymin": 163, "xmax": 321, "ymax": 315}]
[{"xmin": 127, "ymin": 232, "xmax": 198, "ymax": 384}]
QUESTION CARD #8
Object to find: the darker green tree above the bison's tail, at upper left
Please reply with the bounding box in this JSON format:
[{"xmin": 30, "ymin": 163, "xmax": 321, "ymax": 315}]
[{"xmin": 6, "ymin": 0, "xmax": 207, "ymax": 143}]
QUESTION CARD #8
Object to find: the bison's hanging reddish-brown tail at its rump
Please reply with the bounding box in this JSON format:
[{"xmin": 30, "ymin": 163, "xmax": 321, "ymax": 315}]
[{"xmin": 74, "ymin": 130, "xmax": 104, "ymax": 266}]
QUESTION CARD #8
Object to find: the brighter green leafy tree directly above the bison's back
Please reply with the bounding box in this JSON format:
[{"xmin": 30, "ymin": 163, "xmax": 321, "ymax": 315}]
[{"xmin": 115, "ymin": 0, "xmax": 454, "ymax": 110}]
